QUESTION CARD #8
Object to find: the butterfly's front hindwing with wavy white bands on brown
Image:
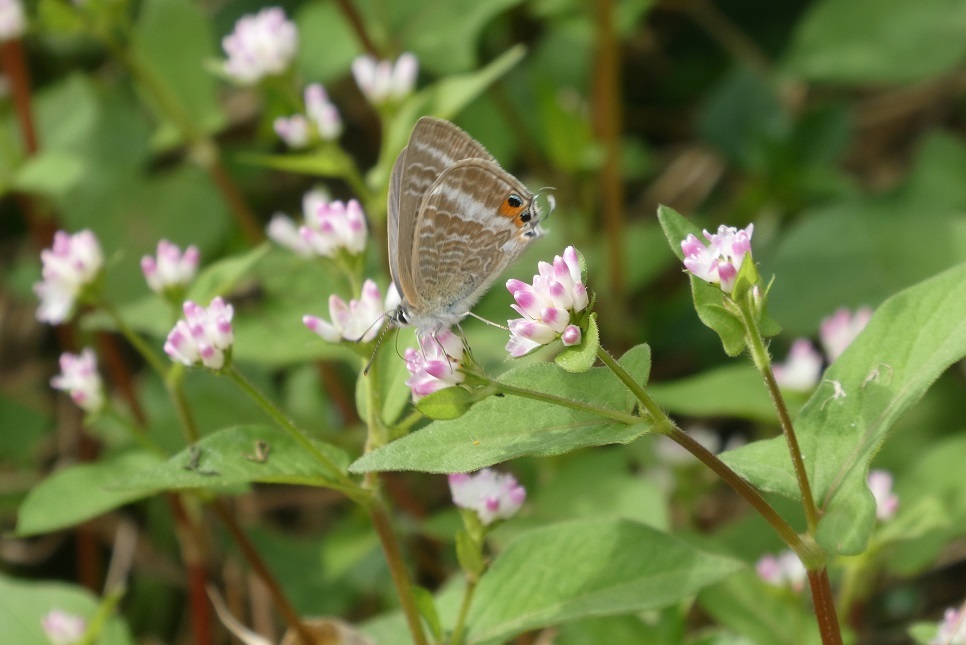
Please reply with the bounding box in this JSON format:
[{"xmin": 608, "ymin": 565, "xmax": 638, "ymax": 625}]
[{"xmin": 410, "ymin": 159, "xmax": 533, "ymax": 314}]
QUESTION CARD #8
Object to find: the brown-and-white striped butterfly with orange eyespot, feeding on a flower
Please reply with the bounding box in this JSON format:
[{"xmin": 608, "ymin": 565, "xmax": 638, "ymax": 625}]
[{"xmin": 388, "ymin": 117, "xmax": 544, "ymax": 334}]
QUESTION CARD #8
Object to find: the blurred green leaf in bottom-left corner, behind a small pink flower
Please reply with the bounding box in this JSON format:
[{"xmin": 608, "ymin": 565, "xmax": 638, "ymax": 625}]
[{"xmin": 0, "ymin": 574, "xmax": 135, "ymax": 645}]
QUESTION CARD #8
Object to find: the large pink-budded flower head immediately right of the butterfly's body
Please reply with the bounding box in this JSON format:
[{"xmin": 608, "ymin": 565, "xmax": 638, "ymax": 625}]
[{"xmin": 506, "ymin": 246, "xmax": 590, "ymax": 357}]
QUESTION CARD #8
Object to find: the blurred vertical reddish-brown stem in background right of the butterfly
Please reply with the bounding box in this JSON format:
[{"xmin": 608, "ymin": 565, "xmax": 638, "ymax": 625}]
[{"xmin": 591, "ymin": 0, "xmax": 624, "ymax": 302}]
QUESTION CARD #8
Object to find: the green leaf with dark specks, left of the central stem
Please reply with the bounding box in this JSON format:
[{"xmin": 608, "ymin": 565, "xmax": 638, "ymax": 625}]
[{"xmin": 111, "ymin": 425, "xmax": 349, "ymax": 494}]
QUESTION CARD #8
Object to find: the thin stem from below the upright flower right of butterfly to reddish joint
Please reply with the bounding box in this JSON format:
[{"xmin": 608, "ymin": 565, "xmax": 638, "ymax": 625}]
[{"xmin": 738, "ymin": 292, "xmax": 819, "ymax": 537}]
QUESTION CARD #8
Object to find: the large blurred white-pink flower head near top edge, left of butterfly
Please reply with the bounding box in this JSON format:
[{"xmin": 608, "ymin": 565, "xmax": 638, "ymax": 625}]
[{"xmin": 221, "ymin": 7, "xmax": 298, "ymax": 85}]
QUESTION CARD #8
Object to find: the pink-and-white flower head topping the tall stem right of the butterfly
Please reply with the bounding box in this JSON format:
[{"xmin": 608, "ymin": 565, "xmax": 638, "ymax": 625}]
[{"xmin": 681, "ymin": 224, "xmax": 755, "ymax": 293}]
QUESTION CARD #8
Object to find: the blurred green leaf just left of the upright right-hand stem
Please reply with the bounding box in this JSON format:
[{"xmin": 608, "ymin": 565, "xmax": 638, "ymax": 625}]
[{"xmin": 647, "ymin": 363, "xmax": 804, "ymax": 423}]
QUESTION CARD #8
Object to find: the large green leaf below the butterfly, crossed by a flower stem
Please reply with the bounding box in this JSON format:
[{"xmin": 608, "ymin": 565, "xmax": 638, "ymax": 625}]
[{"xmin": 350, "ymin": 345, "xmax": 652, "ymax": 473}]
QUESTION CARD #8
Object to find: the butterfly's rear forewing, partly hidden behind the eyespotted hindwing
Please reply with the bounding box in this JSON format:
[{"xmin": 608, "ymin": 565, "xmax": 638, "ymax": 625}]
[{"xmin": 388, "ymin": 117, "xmax": 495, "ymax": 303}]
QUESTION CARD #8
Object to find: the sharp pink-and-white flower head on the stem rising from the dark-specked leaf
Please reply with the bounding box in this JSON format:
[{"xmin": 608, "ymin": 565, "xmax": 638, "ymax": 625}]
[{"xmin": 164, "ymin": 296, "xmax": 235, "ymax": 370}]
